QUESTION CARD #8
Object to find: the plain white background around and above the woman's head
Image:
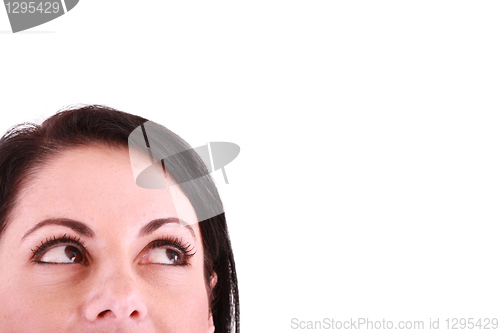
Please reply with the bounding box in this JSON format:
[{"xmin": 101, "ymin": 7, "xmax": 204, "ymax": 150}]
[{"xmin": 0, "ymin": 0, "xmax": 500, "ymax": 333}]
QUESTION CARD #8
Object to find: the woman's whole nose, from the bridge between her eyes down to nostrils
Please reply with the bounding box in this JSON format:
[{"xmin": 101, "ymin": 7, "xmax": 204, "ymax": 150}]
[{"xmin": 84, "ymin": 253, "xmax": 147, "ymax": 321}]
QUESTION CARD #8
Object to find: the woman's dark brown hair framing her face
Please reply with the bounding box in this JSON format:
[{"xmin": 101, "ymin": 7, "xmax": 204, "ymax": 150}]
[{"xmin": 0, "ymin": 105, "xmax": 239, "ymax": 333}]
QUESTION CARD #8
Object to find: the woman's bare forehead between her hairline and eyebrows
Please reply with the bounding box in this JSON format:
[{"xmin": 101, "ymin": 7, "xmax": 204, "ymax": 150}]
[{"xmin": 13, "ymin": 146, "xmax": 197, "ymax": 236}]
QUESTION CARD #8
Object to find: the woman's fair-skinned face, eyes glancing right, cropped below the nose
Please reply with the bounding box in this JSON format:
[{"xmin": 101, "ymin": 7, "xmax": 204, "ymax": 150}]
[{"xmin": 0, "ymin": 147, "xmax": 215, "ymax": 333}]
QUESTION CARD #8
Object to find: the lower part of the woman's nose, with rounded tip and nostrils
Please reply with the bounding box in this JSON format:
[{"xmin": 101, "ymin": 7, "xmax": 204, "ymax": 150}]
[{"xmin": 83, "ymin": 272, "xmax": 147, "ymax": 322}]
